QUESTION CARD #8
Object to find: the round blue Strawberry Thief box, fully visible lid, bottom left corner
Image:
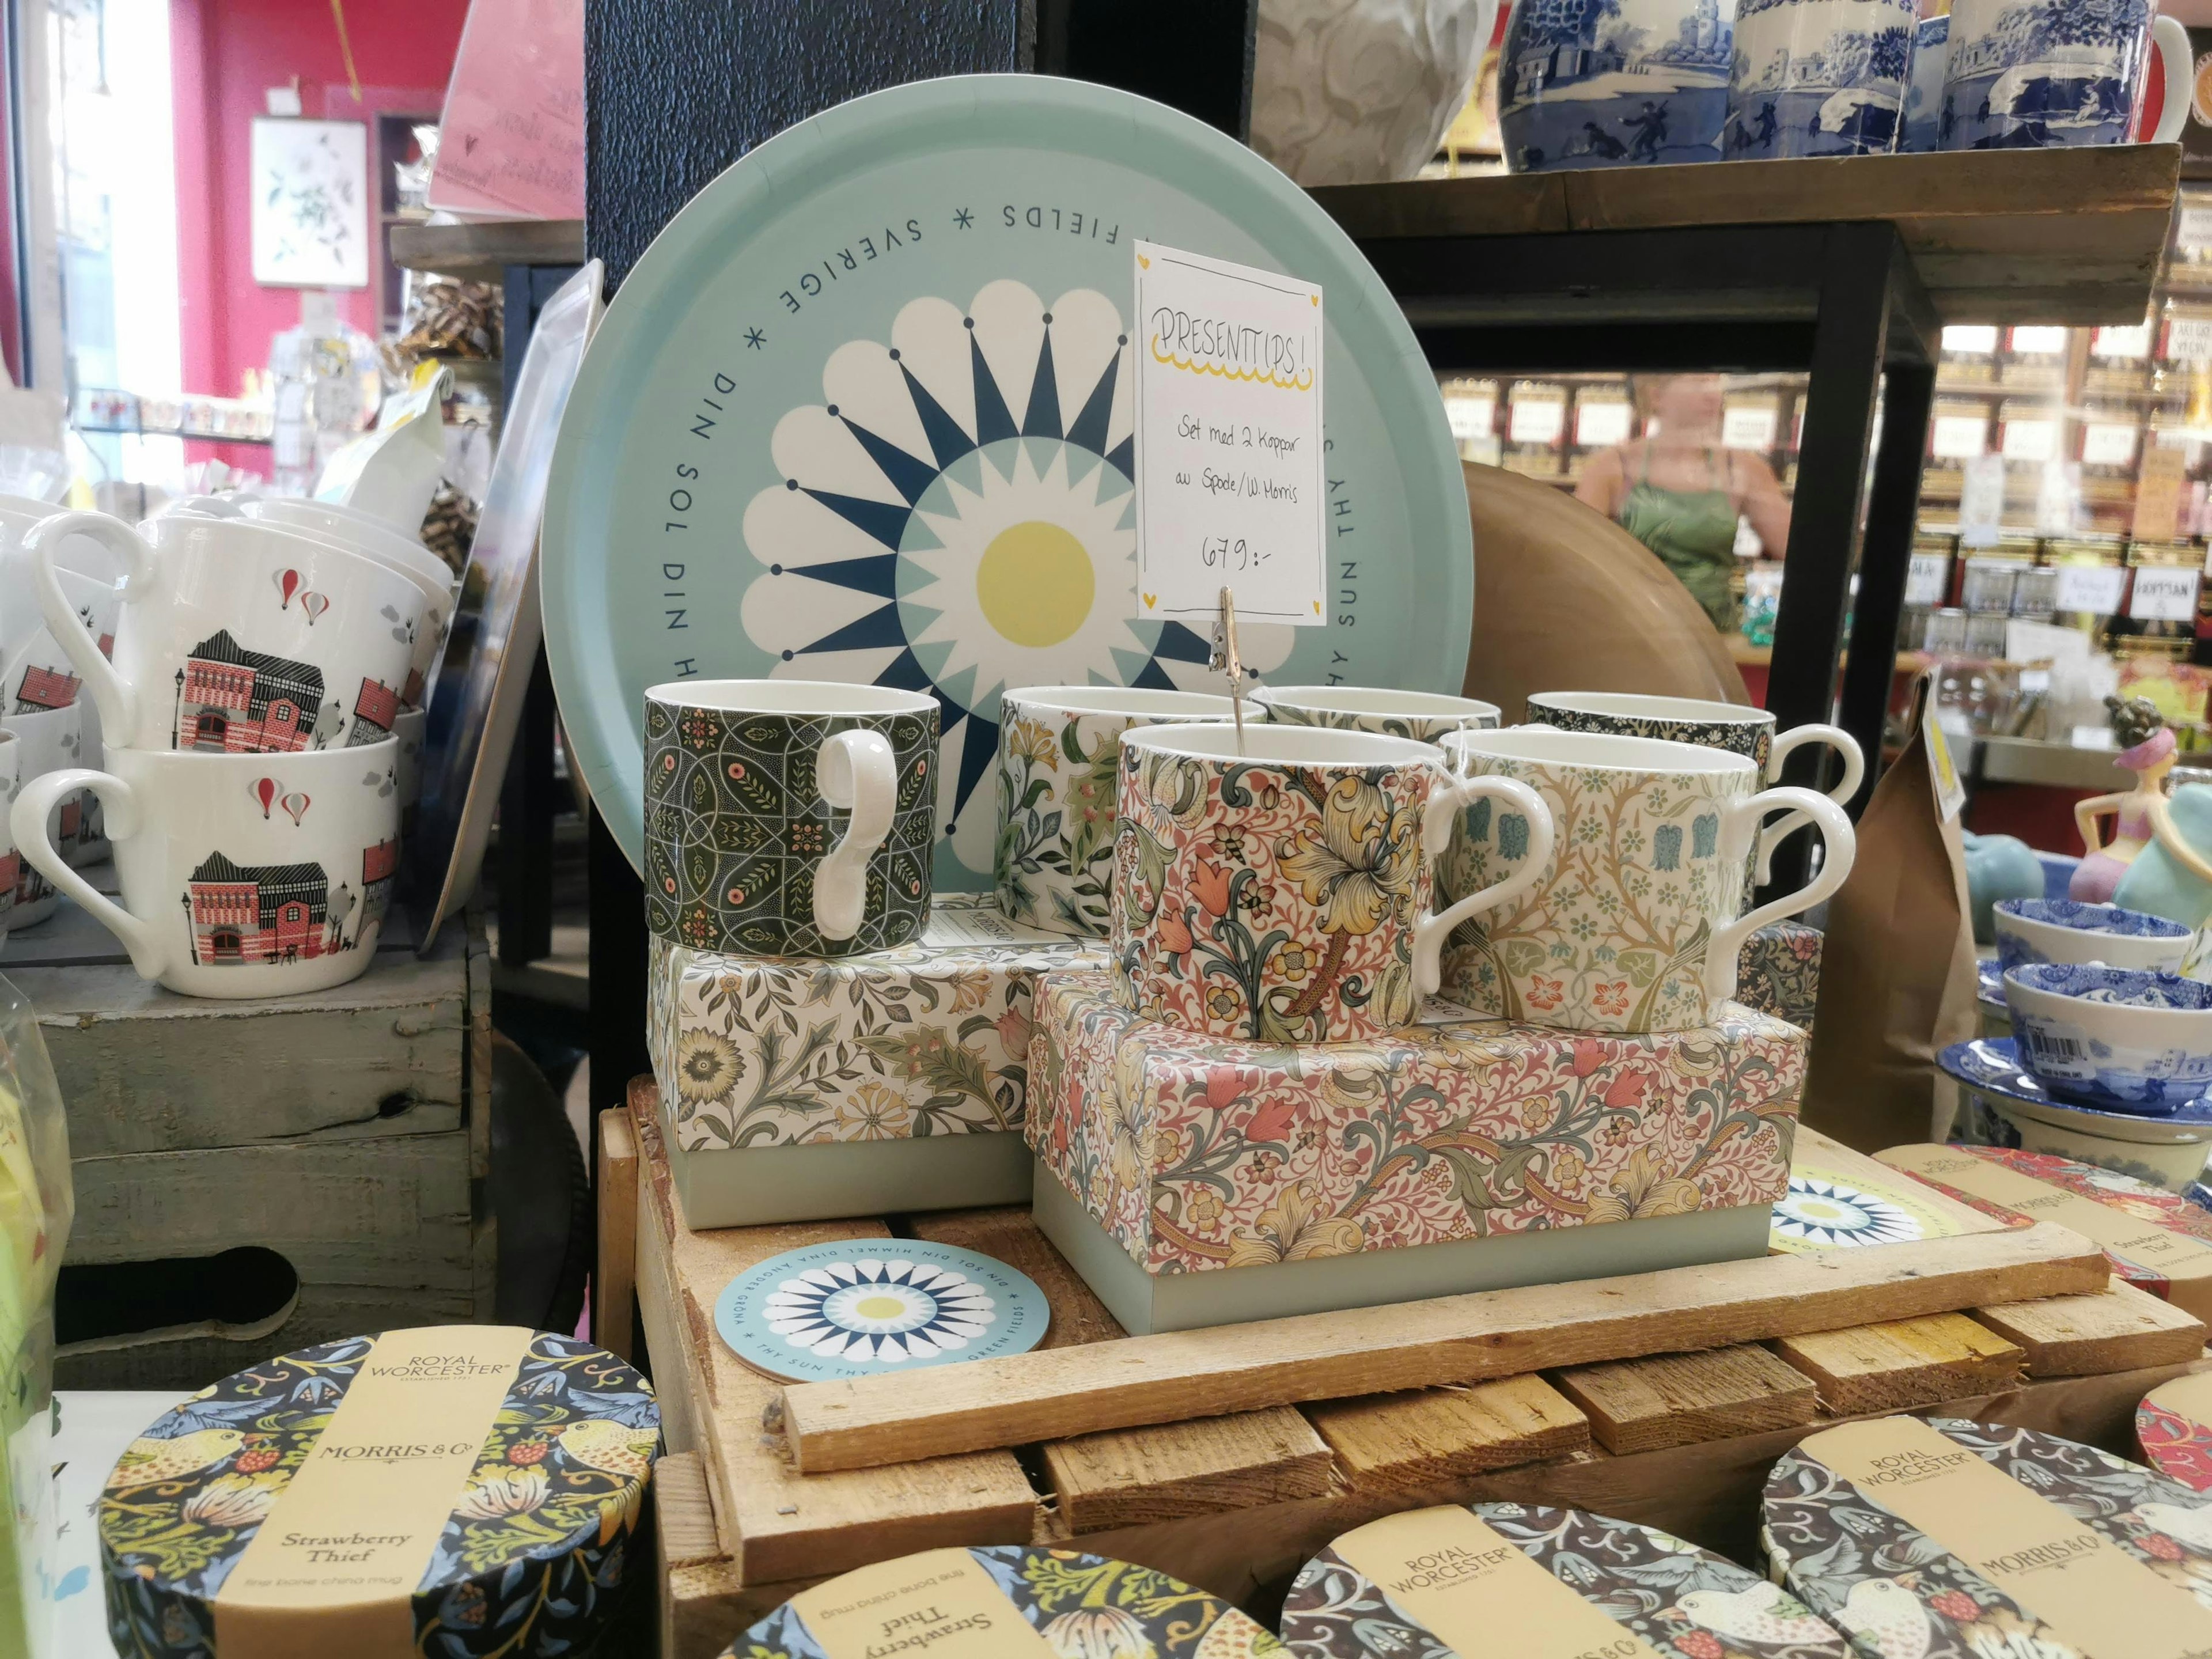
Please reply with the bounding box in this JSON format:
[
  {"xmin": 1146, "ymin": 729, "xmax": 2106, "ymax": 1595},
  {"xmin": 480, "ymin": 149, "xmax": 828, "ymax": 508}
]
[{"xmin": 100, "ymin": 1325, "xmax": 661, "ymax": 1659}]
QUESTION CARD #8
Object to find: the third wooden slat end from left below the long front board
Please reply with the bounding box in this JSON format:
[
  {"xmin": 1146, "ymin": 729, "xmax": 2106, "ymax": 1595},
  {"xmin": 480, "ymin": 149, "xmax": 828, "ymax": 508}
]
[{"xmin": 1305, "ymin": 1376, "xmax": 1590, "ymax": 1491}]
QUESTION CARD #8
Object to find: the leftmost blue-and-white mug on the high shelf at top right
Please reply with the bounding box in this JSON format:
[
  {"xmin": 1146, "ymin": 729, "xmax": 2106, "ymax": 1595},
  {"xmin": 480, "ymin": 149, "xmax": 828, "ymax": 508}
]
[{"xmin": 1498, "ymin": 0, "xmax": 1736, "ymax": 173}]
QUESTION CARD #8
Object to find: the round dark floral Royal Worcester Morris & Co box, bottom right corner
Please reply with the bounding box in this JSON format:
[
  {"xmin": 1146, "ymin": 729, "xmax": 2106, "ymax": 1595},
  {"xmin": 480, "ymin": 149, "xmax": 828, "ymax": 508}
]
[{"xmin": 1761, "ymin": 1418, "xmax": 2212, "ymax": 1659}]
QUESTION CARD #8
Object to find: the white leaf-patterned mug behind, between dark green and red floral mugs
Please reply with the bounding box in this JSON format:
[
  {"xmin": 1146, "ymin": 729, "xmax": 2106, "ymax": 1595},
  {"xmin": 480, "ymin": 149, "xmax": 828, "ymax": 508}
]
[{"xmin": 991, "ymin": 685, "xmax": 1261, "ymax": 938}]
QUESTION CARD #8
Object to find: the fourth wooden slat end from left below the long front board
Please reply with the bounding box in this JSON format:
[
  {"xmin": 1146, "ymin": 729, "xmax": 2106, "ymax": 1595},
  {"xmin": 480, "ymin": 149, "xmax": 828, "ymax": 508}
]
[{"xmin": 1553, "ymin": 1345, "xmax": 1816, "ymax": 1451}]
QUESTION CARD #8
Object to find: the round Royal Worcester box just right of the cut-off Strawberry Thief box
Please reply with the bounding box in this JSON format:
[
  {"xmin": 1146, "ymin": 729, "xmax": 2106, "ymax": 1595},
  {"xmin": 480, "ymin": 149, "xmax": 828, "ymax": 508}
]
[{"xmin": 1283, "ymin": 1504, "xmax": 1851, "ymax": 1659}]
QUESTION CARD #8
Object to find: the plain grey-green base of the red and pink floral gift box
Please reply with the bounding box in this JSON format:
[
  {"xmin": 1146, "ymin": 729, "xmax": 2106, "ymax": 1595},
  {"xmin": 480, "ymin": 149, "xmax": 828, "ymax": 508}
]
[{"xmin": 1033, "ymin": 1164, "xmax": 1774, "ymax": 1336}]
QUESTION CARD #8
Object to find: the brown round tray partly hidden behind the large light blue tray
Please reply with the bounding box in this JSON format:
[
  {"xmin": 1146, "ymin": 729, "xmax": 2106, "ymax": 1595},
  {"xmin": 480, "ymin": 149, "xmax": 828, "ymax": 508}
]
[{"xmin": 1462, "ymin": 463, "xmax": 1752, "ymax": 726}]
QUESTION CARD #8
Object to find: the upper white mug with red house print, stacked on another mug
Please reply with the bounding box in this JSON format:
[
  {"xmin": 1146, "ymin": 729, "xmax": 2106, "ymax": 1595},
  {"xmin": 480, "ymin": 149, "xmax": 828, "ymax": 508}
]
[{"xmin": 24, "ymin": 513, "xmax": 425, "ymax": 754}]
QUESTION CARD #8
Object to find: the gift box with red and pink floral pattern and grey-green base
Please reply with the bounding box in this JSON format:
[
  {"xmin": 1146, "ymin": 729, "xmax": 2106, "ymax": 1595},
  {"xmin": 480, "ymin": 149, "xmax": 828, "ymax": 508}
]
[{"xmin": 1029, "ymin": 971, "xmax": 1805, "ymax": 1334}]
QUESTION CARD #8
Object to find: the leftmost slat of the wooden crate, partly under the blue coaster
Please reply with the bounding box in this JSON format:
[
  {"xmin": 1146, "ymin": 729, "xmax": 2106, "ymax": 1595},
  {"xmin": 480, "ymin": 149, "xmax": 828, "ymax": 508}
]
[{"xmin": 630, "ymin": 1077, "xmax": 1037, "ymax": 1592}]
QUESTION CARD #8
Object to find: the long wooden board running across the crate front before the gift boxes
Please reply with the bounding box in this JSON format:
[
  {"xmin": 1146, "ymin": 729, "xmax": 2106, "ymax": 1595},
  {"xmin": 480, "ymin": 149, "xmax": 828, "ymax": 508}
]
[{"xmin": 783, "ymin": 1224, "xmax": 2108, "ymax": 1473}]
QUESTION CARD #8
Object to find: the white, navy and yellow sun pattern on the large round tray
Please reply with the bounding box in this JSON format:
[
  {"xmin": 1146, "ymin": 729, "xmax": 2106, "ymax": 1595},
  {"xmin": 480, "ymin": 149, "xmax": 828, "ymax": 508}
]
[{"xmin": 743, "ymin": 279, "xmax": 1294, "ymax": 872}]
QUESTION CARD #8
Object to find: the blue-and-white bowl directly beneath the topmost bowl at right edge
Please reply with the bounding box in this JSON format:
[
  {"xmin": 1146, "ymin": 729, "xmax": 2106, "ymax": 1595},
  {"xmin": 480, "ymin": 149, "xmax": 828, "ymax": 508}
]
[{"xmin": 2004, "ymin": 962, "xmax": 2212, "ymax": 1113}]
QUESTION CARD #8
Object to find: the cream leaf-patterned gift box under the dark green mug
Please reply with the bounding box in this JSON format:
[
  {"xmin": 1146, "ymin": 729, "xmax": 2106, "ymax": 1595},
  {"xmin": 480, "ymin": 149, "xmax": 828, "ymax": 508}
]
[{"xmin": 646, "ymin": 893, "xmax": 1106, "ymax": 1228}]
